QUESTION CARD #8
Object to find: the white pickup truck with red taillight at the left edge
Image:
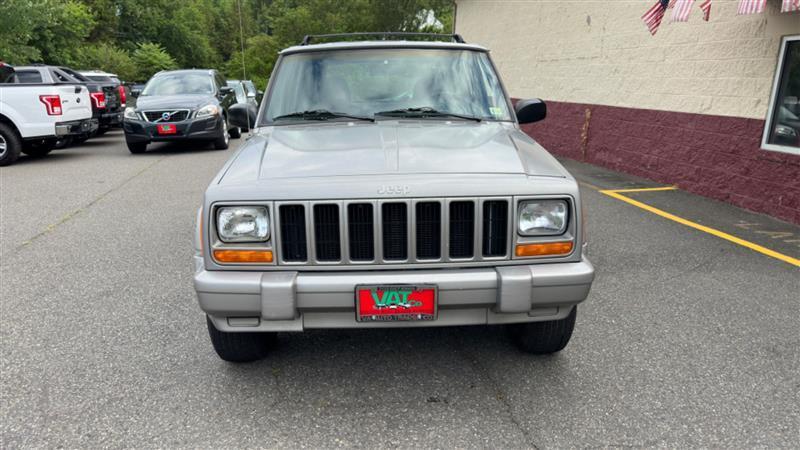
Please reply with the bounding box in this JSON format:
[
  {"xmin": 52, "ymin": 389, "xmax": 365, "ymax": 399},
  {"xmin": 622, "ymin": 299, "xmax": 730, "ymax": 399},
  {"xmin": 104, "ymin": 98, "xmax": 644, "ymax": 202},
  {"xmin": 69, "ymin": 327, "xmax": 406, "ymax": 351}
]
[{"xmin": 0, "ymin": 62, "xmax": 97, "ymax": 166}]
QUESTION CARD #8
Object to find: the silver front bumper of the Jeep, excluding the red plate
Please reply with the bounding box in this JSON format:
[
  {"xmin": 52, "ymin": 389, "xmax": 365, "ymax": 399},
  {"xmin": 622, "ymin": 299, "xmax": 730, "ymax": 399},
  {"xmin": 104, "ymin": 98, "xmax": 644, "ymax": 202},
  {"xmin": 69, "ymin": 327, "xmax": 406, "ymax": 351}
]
[{"xmin": 194, "ymin": 256, "xmax": 594, "ymax": 331}]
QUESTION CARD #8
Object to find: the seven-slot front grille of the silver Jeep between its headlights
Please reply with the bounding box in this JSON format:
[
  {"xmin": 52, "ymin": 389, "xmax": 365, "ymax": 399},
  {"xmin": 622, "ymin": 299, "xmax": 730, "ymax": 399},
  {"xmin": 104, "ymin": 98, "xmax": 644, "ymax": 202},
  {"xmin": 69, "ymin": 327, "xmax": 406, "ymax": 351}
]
[{"xmin": 276, "ymin": 198, "xmax": 512, "ymax": 265}]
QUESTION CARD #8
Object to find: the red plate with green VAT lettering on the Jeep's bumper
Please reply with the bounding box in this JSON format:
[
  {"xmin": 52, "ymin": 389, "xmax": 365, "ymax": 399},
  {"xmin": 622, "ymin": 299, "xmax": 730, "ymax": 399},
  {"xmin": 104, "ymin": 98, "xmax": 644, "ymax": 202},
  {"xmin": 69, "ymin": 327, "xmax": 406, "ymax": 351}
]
[{"xmin": 356, "ymin": 284, "xmax": 436, "ymax": 322}]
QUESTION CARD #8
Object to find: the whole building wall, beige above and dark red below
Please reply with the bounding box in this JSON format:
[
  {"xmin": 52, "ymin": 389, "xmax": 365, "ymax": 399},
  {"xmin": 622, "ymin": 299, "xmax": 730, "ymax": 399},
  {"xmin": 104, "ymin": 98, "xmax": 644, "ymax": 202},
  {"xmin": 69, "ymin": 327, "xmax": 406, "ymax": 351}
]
[{"xmin": 456, "ymin": 0, "xmax": 800, "ymax": 223}]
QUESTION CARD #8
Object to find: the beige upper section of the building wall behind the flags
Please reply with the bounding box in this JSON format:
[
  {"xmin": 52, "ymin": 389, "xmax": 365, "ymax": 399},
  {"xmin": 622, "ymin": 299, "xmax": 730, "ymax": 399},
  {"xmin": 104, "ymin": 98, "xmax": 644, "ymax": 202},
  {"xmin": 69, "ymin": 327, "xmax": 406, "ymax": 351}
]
[{"xmin": 456, "ymin": 0, "xmax": 800, "ymax": 119}]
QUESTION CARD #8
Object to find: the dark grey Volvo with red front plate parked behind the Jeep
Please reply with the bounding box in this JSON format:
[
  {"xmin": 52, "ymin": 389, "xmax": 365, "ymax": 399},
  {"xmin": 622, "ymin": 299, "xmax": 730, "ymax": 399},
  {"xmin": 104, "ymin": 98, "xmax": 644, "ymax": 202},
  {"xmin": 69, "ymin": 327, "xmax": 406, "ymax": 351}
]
[{"xmin": 123, "ymin": 69, "xmax": 242, "ymax": 153}]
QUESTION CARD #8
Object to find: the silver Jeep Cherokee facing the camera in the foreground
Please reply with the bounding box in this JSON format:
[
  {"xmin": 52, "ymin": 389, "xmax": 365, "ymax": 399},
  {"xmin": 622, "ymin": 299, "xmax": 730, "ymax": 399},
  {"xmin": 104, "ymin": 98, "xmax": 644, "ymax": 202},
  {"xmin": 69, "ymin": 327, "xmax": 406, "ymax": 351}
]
[{"xmin": 194, "ymin": 35, "xmax": 594, "ymax": 362}]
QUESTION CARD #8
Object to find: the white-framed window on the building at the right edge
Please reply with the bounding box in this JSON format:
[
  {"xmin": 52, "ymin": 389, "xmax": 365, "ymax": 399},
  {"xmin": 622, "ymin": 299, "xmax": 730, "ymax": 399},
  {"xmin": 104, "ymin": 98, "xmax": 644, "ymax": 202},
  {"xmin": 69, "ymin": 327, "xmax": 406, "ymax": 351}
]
[{"xmin": 761, "ymin": 36, "xmax": 800, "ymax": 155}]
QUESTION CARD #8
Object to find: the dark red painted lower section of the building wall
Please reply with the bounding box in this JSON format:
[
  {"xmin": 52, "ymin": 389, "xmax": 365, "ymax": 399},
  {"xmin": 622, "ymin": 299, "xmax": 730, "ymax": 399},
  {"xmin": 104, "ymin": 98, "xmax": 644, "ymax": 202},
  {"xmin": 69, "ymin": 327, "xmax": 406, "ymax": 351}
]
[{"xmin": 522, "ymin": 102, "xmax": 800, "ymax": 224}]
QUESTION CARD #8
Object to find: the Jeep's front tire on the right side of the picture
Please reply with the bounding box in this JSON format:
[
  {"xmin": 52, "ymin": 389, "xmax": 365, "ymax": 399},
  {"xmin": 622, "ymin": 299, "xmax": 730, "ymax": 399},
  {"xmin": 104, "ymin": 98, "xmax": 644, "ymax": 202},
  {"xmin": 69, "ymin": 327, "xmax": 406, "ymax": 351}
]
[{"xmin": 509, "ymin": 306, "xmax": 578, "ymax": 355}]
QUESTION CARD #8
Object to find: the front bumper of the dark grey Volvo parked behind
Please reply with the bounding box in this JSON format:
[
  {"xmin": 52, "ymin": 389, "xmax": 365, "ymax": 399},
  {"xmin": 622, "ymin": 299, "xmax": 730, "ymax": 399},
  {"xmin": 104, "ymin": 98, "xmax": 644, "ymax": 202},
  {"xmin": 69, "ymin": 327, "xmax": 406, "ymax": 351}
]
[{"xmin": 122, "ymin": 116, "xmax": 222, "ymax": 143}]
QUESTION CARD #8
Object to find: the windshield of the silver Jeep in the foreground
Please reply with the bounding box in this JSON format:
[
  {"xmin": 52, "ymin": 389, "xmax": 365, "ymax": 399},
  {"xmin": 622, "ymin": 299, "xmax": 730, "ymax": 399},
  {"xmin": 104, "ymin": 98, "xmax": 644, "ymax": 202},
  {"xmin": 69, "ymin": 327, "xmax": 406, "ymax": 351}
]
[{"xmin": 265, "ymin": 49, "xmax": 511, "ymax": 122}]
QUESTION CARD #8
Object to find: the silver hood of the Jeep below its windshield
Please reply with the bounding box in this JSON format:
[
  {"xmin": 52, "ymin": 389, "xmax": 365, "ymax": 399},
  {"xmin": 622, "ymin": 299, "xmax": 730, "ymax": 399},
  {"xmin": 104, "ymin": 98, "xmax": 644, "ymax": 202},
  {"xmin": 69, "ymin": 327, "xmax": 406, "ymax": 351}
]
[{"xmin": 220, "ymin": 121, "xmax": 567, "ymax": 183}]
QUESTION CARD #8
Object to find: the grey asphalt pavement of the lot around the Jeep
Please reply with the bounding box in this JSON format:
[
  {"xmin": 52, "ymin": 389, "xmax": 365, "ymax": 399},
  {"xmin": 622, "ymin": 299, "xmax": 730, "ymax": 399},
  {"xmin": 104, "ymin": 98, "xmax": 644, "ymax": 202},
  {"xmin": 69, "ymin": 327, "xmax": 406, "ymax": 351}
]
[{"xmin": 0, "ymin": 132, "xmax": 800, "ymax": 448}]
